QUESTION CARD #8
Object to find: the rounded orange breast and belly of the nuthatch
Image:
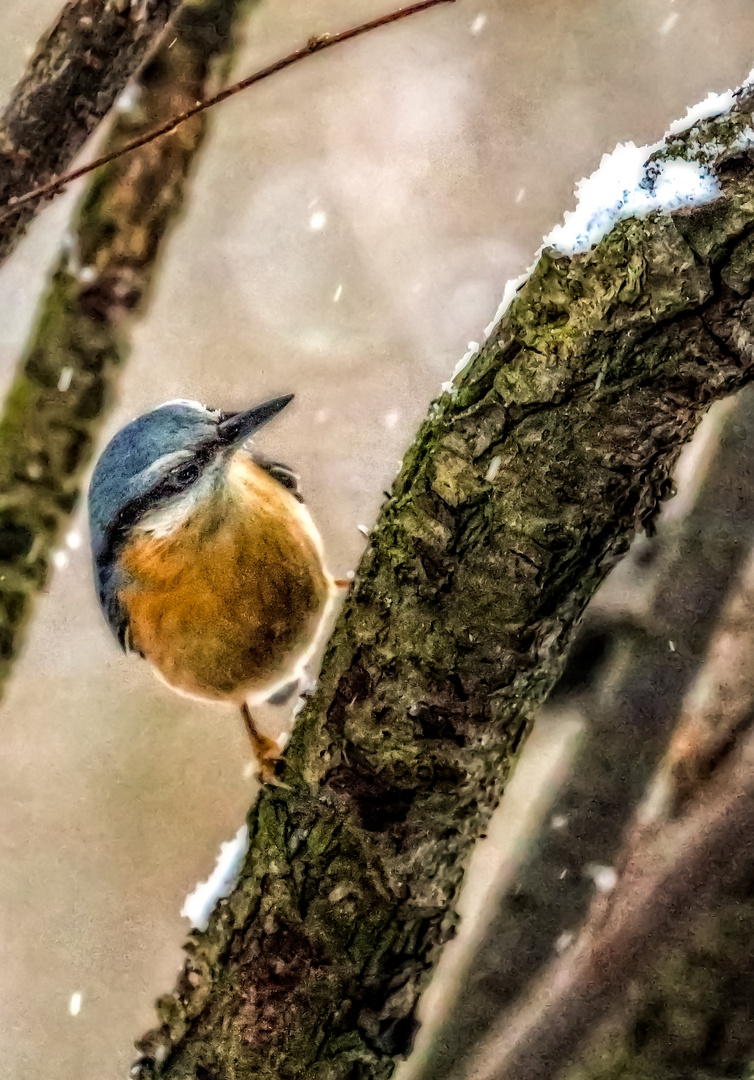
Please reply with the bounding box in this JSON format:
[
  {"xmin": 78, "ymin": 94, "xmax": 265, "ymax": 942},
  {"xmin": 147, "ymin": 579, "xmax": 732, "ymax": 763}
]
[{"xmin": 119, "ymin": 451, "xmax": 331, "ymax": 701}]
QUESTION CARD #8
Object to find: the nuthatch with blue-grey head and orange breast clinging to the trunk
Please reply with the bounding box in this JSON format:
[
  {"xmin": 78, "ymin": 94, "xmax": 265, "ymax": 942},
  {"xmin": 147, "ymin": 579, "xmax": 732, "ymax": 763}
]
[{"xmin": 89, "ymin": 395, "xmax": 348, "ymax": 779}]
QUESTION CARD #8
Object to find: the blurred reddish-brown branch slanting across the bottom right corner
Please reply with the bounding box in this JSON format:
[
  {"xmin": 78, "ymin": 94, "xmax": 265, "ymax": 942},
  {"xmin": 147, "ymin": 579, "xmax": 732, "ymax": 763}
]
[{"xmin": 468, "ymin": 717, "xmax": 754, "ymax": 1080}]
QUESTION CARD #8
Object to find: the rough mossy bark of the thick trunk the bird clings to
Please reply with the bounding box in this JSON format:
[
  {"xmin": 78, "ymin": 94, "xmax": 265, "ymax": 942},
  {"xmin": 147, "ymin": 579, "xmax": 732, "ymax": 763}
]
[{"xmin": 132, "ymin": 92, "xmax": 754, "ymax": 1080}]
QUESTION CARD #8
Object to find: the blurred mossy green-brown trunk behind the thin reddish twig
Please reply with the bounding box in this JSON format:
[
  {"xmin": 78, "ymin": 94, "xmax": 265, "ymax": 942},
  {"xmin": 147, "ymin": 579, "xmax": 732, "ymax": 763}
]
[{"xmin": 0, "ymin": 0, "xmax": 250, "ymax": 683}]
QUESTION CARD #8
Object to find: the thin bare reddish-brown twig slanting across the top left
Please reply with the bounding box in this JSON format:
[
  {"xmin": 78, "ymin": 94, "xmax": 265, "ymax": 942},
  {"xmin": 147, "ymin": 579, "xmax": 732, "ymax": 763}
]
[{"xmin": 0, "ymin": 0, "xmax": 455, "ymax": 221}]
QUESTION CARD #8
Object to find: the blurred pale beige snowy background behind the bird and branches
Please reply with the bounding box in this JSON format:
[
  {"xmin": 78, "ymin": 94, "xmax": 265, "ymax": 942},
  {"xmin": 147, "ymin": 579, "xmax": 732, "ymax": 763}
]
[{"xmin": 0, "ymin": 0, "xmax": 754, "ymax": 1080}]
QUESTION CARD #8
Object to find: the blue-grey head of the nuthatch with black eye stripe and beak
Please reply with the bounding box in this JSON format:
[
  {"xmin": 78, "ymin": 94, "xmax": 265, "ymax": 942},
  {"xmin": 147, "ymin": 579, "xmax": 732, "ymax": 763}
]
[{"xmin": 89, "ymin": 394, "xmax": 293, "ymax": 637}]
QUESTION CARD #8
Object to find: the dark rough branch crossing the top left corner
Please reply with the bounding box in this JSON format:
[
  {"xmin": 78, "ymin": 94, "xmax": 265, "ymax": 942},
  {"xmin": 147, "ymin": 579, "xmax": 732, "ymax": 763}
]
[{"xmin": 0, "ymin": 0, "xmax": 179, "ymax": 261}]
